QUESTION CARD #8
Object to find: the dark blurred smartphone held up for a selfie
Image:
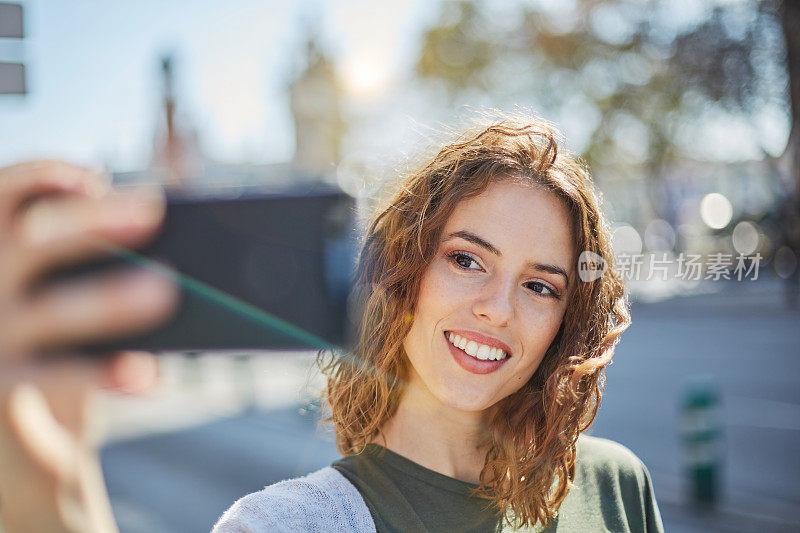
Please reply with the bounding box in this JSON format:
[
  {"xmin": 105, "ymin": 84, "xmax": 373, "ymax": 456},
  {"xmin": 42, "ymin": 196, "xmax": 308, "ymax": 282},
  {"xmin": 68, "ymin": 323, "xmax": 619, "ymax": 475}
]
[{"xmin": 39, "ymin": 185, "xmax": 358, "ymax": 354}]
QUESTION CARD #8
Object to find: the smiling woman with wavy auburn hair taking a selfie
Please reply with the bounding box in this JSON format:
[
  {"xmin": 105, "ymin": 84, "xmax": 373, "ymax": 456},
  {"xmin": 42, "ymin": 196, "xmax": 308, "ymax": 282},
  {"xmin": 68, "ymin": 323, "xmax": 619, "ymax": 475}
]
[{"xmin": 0, "ymin": 114, "xmax": 662, "ymax": 532}]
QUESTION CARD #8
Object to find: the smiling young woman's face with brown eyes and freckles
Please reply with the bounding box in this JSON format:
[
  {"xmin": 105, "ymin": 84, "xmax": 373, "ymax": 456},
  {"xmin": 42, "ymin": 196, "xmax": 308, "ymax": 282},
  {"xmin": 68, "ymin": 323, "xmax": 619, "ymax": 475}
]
[{"xmin": 404, "ymin": 180, "xmax": 575, "ymax": 411}]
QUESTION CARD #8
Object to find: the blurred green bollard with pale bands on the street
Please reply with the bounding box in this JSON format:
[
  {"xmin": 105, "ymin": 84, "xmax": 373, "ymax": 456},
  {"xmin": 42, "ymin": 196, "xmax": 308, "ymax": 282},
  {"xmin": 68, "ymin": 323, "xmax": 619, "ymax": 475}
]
[{"xmin": 681, "ymin": 376, "xmax": 722, "ymax": 505}]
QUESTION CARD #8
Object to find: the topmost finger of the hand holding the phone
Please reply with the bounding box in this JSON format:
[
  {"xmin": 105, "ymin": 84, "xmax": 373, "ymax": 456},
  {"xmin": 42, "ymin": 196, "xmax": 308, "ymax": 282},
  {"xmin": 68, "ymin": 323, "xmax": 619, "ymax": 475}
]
[{"xmin": 0, "ymin": 161, "xmax": 109, "ymax": 227}]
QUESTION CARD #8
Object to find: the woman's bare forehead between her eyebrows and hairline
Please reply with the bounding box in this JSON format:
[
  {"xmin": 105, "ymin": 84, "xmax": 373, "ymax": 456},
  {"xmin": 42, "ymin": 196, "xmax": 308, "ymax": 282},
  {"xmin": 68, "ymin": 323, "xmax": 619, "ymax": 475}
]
[{"xmin": 444, "ymin": 180, "xmax": 574, "ymax": 264}]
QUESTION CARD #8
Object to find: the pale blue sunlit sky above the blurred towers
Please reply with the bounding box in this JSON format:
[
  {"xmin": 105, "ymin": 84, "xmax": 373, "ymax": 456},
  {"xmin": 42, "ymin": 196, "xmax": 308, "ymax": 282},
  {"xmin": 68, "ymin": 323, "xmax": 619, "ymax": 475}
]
[{"xmin": 0, "ymin": 0, "xmax": 436, "ymax": 170}]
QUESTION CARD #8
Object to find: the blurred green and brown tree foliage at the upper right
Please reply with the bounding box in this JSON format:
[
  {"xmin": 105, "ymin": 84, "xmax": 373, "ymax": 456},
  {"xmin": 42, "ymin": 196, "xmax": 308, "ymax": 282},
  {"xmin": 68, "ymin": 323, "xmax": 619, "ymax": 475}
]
[{"xmin": 416, "ymin": 0, "xmax": 797, "ymax": 229}]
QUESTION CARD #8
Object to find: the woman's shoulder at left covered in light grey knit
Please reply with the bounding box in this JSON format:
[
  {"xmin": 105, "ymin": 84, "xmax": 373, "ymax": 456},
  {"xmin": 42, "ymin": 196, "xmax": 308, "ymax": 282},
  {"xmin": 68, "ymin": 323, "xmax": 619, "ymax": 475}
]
[{"xmin": 212, "ymin": 467, "xmax": 375, "ymax": 533}]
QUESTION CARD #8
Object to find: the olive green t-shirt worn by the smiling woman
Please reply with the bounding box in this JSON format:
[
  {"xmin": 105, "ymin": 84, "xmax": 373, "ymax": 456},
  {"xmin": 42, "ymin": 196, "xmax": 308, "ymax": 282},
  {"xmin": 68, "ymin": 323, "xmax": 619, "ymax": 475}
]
[{"xmin": 331, "ymin": 435, "xmax": 664, "ymax": 533}]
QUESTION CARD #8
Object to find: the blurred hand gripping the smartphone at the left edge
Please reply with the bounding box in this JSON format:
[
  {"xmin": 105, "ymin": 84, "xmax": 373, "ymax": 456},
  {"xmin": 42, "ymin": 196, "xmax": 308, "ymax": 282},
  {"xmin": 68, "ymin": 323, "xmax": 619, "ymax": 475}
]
[{"xmin": 0, "ymin": 161, "xmax": 177, "ymax": 533}]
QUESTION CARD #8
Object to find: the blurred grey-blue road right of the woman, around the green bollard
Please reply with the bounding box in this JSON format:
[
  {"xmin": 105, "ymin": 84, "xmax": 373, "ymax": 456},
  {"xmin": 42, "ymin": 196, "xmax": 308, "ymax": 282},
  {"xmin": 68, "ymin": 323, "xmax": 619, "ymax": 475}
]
[{"xmin": 591, "ymin": 280, "xmax": 800, "ymax": 532}]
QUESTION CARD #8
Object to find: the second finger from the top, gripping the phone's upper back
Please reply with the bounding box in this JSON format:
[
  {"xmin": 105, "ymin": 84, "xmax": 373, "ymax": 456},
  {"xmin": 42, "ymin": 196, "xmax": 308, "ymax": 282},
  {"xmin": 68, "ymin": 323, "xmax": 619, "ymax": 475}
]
[{"xmin": 9, "ymin": 189, "xmax": 165, "ymax": 289}]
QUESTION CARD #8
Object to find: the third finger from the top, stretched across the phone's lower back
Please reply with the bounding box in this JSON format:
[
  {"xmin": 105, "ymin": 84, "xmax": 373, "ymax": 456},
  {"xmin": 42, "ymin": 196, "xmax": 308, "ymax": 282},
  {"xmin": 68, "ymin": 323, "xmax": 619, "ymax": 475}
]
[{"xmin": 0, "ymin": 267, "xmax": 179, "ymax": 360}]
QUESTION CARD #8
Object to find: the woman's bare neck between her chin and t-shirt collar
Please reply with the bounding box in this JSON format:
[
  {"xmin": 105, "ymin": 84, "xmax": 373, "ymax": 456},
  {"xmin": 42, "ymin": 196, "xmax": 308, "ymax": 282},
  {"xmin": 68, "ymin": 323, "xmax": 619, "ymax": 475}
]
[{"xmin": 372, "ymin": 376, "xmax": 488, "ymax": 483}]
